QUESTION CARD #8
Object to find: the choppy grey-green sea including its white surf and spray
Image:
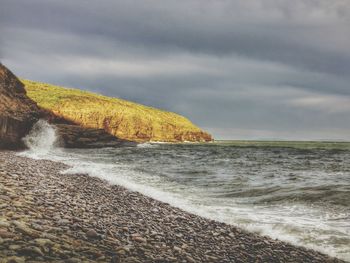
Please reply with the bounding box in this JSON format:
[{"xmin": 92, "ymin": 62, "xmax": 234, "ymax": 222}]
[{"xmin": 21, "ymin": 122, "xmax": 350, "ymax": 261}]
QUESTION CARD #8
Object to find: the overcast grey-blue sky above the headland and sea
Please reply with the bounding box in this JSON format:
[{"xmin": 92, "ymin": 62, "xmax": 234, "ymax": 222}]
[{"xmin": 0, "ymin": 0, "xmax": 350, "ymax": 140}]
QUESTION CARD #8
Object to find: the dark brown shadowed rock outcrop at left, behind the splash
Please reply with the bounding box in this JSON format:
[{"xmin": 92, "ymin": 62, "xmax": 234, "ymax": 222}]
[{"xmin": 0, "ymin": 64, "xmax": 132, "ymax": 149}]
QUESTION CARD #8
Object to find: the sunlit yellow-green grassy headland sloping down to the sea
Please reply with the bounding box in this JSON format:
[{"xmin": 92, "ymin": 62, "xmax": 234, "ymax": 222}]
[{"xmin": 22, "ymin": 80, "xmax": 212, "ymax": 142}]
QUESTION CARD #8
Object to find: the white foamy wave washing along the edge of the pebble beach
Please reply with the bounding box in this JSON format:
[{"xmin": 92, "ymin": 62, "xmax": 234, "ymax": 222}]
[{"xmin": 58, "ymin": 158, "xmax": 349, "ymax": 259}]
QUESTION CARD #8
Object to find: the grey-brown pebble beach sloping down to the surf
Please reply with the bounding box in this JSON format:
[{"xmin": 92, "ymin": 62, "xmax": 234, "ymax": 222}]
[{"xmin": 0, "ymin": 151, "xmax": 344, "ymax": 263}]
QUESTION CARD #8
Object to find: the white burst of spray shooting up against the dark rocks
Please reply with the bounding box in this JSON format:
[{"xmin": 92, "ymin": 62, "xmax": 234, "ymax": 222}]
[{"xmin": 23, "ymin": 120, "xmax": 58, "ymax": 158}]
